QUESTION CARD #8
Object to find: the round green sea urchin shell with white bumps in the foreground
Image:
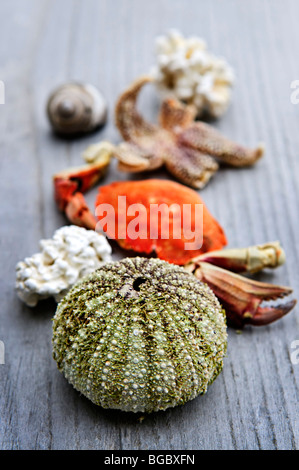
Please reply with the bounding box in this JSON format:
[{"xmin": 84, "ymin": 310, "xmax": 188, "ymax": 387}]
[{"xmin": 53, "ymin": 258, "xmax": 227, "ymax": 412}]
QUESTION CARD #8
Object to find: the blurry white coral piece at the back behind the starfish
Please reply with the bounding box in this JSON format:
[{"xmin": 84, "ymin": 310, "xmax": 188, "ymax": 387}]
[{"xmin": 152, "ymin": 30, "xmax": 234, "ymax": 117}]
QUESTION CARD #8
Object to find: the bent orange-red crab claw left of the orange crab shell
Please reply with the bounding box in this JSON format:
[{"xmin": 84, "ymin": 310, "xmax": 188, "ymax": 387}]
[{"xmin": 53, "ymin": 153, "xmax": 110, "ymax": 230}]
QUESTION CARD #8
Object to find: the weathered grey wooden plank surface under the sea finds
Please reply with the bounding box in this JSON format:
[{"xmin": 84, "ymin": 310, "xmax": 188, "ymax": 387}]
[{"xmin": 0, "ymin": 0, "xmax": 299, "ymax": 450}]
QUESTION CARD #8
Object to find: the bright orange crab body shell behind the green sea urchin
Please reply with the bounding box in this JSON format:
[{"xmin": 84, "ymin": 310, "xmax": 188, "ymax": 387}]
[{"xmin": 96, "ymin": 179, "xmax": 227, "ymax": 265}]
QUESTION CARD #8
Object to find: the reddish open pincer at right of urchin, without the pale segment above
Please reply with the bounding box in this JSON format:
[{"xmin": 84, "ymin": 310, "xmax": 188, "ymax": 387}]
[{"xmin": 194, "ymin": 262, "xmax": 296, "ymax": 328}]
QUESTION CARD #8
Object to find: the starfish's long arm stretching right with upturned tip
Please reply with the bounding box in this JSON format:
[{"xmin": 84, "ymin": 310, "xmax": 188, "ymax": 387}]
[{"xmin": 178, "ymin": 122, "xmax": 264, "ymax": 167}]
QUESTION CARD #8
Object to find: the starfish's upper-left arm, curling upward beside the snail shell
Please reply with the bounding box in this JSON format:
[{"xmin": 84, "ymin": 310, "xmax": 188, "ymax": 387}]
[{"xmin": 115, "ymin": 76, "xmax": 157, "ymax": 142}]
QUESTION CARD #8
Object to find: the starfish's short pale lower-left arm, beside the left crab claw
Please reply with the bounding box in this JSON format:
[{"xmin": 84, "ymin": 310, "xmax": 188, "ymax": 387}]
[{"xmin": 114, "ymin": 142, "xmax": 163, "ymax": 173}]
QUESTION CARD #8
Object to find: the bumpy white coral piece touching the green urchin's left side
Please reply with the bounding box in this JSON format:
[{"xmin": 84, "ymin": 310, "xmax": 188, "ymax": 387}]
[{"xmin": 16, "ymin": 225, "xmax": 112, "ymax": 307}]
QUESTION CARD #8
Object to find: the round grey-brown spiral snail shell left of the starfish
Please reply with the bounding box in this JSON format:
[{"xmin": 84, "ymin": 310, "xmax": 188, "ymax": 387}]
[{"xmin": 47, "ymin": 82, "xmax": 107, "ymax": 135}]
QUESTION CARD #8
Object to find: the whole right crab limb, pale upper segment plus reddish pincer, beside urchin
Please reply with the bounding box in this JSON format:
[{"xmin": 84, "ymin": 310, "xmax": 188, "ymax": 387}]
[{"xmin": 185, "ymin": 242, "xmax": 296, "ymax": 328}]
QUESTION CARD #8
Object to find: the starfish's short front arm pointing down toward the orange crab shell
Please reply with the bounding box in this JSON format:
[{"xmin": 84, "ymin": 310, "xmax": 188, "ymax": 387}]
[{"xmin": 165, "ymin": 146, "xmax": 218, "ymax": 189}]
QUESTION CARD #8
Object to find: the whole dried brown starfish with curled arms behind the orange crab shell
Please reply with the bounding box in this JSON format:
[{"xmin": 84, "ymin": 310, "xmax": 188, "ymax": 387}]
[{"xmin": 113, "ymin": 76, "xmax": 264, "ymax": 189}]
